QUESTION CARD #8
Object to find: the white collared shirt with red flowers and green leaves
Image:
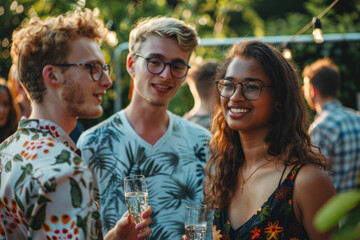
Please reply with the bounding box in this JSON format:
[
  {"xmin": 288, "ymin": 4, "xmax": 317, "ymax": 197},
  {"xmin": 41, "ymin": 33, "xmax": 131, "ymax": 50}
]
[{"xmin": 0, "ymin": 118, "xmax": 101, "ymax": 240}]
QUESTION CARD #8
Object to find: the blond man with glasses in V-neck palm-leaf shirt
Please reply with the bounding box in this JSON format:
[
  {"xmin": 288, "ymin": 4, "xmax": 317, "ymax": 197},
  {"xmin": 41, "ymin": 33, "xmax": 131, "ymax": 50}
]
[{"xmin": 78, "ymin": 17, "xmax": 210, "ymax": 240}]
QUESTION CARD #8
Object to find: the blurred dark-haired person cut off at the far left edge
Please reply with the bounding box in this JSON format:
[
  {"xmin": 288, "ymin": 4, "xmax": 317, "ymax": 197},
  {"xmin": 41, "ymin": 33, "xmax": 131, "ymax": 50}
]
[{"xmin": 0, "ymin": 78, "xmax": 20, "ymax": 142}]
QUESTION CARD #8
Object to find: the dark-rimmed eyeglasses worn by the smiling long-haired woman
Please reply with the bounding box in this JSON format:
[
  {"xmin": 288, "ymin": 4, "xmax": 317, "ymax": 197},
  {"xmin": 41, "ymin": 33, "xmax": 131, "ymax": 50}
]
[{"xmin": 216, "ymin": 79, "xmax": 272, "ymax": 100}]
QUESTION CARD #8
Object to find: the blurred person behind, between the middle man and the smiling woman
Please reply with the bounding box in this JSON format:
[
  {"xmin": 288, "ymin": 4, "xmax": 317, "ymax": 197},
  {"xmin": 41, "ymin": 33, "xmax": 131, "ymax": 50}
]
[{"xmin": 184, "ymin": 60, "xmax": 219, "ymax": 130}]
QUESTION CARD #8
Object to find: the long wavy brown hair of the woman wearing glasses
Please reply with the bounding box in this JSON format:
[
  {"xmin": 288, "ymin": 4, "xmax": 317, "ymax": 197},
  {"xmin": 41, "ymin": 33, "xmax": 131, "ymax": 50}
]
[{"xmin": 204, "ymin": 41, "xmax": 327, "ymax": 208}]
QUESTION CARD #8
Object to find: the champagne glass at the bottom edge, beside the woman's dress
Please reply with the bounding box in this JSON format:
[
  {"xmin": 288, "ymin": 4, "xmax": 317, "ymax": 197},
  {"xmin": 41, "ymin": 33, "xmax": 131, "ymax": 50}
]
[{"xmin": 185, "ymin": 204, "xmax": 207, "ymax": 240}]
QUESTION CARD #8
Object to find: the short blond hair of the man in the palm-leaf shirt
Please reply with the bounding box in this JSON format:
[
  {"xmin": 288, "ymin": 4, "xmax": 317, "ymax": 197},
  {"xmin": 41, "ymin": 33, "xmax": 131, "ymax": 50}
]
[{"xmin": 129, "ymin": 17, "xmax": 198, "ymax": 54}]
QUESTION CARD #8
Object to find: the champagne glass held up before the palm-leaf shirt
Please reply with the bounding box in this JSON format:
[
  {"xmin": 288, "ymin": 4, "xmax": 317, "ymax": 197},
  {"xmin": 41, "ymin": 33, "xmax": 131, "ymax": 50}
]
[{"xmin": 124, "ymin": 175, "xmax": 148, "ymax": 224}]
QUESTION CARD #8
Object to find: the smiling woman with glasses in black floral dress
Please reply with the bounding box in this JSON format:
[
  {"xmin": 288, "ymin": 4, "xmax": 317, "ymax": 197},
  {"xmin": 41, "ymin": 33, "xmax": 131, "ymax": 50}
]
[{"xmin": 204, "ymin": 41, "xmax": 335, "ymax": 240}]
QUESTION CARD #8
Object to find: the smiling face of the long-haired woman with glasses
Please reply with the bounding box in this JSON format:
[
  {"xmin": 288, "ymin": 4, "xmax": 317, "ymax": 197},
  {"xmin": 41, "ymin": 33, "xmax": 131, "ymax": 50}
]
[{"xmin": 220, "ymin": 57, "xmax": 275, "ymax": 132}]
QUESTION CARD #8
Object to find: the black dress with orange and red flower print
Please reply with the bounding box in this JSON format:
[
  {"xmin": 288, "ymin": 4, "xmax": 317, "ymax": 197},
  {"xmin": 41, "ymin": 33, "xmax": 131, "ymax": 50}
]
[{"xmin": 213, "ymin": 164, "xmax": 309, "ymax": 240}]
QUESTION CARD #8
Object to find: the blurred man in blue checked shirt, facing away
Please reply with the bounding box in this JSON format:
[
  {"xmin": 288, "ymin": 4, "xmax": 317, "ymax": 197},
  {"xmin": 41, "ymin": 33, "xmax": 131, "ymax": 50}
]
[{"xmin": 302, "ymin": 58, "xmax": 360, "ymax": 193}]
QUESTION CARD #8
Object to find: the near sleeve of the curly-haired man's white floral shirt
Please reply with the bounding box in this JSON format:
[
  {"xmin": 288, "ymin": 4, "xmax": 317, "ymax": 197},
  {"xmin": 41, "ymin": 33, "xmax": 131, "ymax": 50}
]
[{"xmin": 27, "ymin": 150, "xmax": 97, "ymax": 239}]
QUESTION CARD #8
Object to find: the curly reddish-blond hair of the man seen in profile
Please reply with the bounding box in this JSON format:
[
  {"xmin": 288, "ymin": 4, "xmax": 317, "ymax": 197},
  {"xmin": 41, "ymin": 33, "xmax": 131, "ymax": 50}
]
[{"xmin": 11, "ymin": 9, "xmax": 107, "ymax": 102}]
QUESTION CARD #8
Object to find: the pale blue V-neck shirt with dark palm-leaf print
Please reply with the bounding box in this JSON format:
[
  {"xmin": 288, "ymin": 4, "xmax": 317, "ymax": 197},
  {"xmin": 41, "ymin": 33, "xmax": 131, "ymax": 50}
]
[{"xmin": 78, "ymin": 111, "xmax": 211, "ymax": 240}]
